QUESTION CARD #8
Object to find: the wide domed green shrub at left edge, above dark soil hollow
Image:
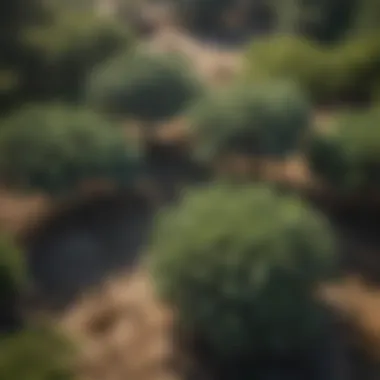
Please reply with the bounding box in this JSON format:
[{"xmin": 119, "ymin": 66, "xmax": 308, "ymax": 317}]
[{"xmin": 0, "ymin": 105, "xmax": 140, "ymax": 193}]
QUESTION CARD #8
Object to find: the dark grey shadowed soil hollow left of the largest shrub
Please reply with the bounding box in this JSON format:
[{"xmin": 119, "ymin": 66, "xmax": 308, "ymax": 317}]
[{"xmin": 28, "ymin": 190, "xmax": 153, "ymax": 306}]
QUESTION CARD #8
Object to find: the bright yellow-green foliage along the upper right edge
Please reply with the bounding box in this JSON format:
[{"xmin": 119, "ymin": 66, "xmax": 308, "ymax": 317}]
[{"xmin": 245, "ymin": 35, "xmax": 380, "ymax": 103}]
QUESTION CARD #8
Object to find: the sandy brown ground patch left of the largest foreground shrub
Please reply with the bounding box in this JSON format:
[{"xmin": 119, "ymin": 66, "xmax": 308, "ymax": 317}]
[{"xmin": 60, "ymin": 271, "xmax": 179, "ymax": 380}]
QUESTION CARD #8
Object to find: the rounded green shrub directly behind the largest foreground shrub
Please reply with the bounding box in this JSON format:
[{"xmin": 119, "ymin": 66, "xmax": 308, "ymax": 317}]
[{"xmin": 190, "ymin": 82, "xmax": 310, "ymax": 159}]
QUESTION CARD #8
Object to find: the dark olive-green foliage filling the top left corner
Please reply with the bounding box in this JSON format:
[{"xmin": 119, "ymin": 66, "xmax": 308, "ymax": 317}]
[{"xmin": 0, "ymin": 0, "xmax": 133, "ymax": 111}]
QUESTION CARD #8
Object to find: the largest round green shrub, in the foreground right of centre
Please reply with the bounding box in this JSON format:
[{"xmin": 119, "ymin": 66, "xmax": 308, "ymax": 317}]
[{"xmin": 150, "ymin": 185, "xmax": 335, "ymax": 357}]
